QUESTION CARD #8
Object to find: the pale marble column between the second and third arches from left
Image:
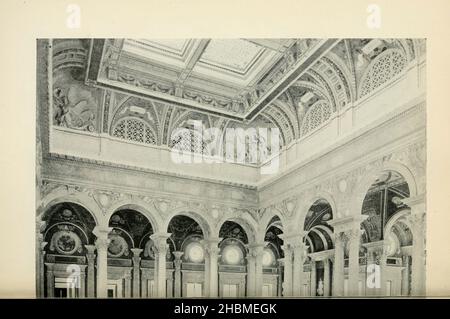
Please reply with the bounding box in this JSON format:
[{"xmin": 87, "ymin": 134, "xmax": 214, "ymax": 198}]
[{"xmin": 150, "ymin": 233, "xmax": 170, "ymax": 298}]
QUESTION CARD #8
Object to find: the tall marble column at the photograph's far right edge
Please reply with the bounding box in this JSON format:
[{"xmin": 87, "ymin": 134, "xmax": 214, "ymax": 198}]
[{"xmin": 403, "ymin": 196, "xmax": 426, "ymax": 296}]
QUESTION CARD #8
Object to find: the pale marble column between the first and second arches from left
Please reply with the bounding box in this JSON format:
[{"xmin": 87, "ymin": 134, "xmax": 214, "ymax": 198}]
[{"xmin": 92, "ymin": 226, "xmax": 112, "ymax": 298}]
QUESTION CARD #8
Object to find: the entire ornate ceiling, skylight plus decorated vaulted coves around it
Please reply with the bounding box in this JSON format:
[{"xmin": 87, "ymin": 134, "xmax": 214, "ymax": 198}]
[{"xmin": 49, "ymin": 39, "xmax": 425, "ymax": 160}]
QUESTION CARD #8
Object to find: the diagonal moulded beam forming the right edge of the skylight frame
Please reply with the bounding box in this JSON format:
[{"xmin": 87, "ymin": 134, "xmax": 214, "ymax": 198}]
[{"xmin": 245, "ymin": 39, "xmax": 341, "ymax": 121}]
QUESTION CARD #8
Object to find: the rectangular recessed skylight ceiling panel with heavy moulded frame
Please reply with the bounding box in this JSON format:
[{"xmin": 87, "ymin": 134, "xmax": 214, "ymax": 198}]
[{"xmin": 86, "ymin": 39, "xmax": 339, "ymax": 121}]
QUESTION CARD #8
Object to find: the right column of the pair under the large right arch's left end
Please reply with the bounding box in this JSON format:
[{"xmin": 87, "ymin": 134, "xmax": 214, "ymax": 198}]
[{"xmin": 346, "ymin": 229, "xmax": 361, "ymax": 297}]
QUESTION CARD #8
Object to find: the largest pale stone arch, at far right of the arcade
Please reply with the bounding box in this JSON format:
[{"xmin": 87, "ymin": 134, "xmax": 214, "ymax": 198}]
[{"xmin": 349, "ymin": 161, "xmax": 418, "ymax": 216}]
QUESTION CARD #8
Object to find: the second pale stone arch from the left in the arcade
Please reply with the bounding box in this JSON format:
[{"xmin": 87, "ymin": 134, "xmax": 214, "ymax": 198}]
[{"xmin": 105, "ymin": 200, "xmax": 164, "ymax": 233}]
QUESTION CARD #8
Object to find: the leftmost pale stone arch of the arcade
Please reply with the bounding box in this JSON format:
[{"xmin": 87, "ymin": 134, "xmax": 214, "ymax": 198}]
[{"xmin": 37, "ymin": 191, "xmax": 103, "ymax": 226}]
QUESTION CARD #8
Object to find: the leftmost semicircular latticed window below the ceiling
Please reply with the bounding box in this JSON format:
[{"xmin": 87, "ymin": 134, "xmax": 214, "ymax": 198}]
[{"xmin": 112, "ymin": 117, "xmax": 156, "ymax": 144}]
